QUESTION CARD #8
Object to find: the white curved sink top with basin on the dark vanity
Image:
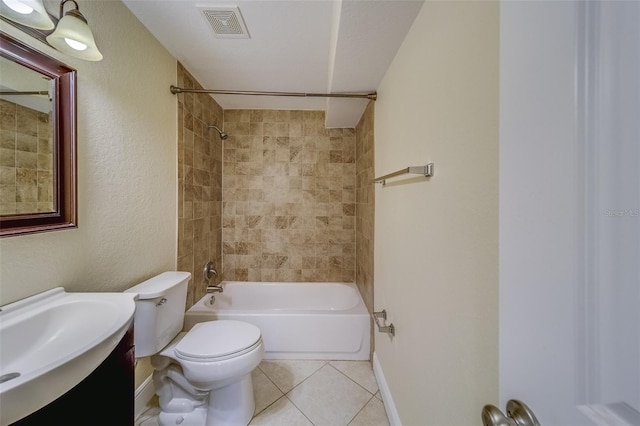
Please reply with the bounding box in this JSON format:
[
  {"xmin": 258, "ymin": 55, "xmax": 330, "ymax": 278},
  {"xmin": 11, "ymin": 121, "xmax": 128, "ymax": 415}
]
[{"xmin": 0, "ymin": 287, "xmax": 136, "ymax": 425}]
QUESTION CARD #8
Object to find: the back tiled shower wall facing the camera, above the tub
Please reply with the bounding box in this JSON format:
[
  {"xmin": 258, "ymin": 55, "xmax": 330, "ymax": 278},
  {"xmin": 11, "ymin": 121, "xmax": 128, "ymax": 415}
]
[{"xmin": 222, "ymin": 110, "xmax": 356, "ymax": 282}]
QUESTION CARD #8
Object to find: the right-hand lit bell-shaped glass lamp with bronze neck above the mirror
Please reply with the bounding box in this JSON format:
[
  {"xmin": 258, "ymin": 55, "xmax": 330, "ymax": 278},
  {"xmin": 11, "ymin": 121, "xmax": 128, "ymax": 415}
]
[{"xmin": 45, "ymin": 0, "xmax": 102, "ymax": 61}]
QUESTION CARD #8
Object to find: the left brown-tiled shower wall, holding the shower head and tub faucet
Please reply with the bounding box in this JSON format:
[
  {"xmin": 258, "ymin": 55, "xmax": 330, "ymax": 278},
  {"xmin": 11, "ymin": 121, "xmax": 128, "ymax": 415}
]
[{"xmin": 177, "ymin": 63, "xmax": 223, "ymax": 308}]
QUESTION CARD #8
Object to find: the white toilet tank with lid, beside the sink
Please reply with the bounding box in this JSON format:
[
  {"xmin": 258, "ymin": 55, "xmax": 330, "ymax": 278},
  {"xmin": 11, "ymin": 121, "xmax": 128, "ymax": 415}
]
[{"xmin": 125, "ymin": 272, "xmax": 191, "ymax": 358}]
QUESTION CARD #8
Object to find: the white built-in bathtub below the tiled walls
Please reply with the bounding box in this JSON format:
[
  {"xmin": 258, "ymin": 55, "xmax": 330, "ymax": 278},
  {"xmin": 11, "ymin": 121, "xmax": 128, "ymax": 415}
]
[{"xmin": 184, "ymin": 281, "xmax": 371, "ymax": 360}]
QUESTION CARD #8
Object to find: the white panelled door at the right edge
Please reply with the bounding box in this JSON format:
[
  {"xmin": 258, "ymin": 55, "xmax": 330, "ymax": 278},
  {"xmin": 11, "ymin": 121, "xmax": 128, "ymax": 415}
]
[{"xmin": 499, "ymin": 1, "xmax": 640, "ymax": 426}]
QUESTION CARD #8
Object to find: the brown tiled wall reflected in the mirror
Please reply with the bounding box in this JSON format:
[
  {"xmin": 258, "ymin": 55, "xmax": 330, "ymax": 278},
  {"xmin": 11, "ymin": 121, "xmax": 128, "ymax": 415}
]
[{"xmin": 0, "ymin": 100, "xmax": 53, "ymax": 215}]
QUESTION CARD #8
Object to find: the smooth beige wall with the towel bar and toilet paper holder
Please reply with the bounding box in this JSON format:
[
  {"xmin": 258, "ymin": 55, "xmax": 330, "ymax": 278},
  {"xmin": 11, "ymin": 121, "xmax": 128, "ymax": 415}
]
[{"xmin": 375, "ymin": 1, "xmax": 499, "ymax": 426}]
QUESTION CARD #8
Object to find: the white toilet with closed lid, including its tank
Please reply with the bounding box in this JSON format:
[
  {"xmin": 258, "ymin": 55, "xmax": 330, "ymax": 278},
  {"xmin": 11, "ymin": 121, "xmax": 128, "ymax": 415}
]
[{"xmin": 126, "ymin": 272, "xmax": 264, "ymax": 426}]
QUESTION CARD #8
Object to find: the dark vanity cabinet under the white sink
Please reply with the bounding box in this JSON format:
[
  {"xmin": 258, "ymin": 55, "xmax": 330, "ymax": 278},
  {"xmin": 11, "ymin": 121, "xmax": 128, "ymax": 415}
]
[{"xmin": 12, "ymin": 326, "xmax": 135, "ymax": 426}]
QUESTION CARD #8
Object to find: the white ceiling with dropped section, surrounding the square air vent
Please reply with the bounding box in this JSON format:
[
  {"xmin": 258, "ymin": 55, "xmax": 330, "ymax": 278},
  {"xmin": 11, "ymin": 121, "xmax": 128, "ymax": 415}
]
[{"xmin": 123, "ymin": 0, "xmax": 424, "ymax": 127}]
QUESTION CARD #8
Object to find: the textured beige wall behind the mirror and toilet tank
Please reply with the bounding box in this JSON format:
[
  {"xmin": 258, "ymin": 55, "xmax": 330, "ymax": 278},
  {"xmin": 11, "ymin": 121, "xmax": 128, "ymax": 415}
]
[{"xmin": 0, "ymin": 1, "xmax": 177, "ymax": 304}]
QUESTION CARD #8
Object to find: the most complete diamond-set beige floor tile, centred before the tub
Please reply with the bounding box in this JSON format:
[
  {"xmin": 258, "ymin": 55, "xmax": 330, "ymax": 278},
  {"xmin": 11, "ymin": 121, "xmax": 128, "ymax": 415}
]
[{"xmin": 287, "ymin": 364, "xmax": 373, "ymax": 426}]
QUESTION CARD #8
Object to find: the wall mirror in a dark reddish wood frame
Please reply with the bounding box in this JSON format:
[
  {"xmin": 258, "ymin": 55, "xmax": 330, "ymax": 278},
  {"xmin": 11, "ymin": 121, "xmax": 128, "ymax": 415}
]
[{"xmin": 0, "ymin": 32, "xmax": 77, "ymax": 237}]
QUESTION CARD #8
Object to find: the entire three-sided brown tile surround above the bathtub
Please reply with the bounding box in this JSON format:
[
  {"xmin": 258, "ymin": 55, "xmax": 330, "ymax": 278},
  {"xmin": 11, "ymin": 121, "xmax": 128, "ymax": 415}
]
[{"xmin": 177, "ymin": 64, "xmax": 374, "ymax": 316}]
